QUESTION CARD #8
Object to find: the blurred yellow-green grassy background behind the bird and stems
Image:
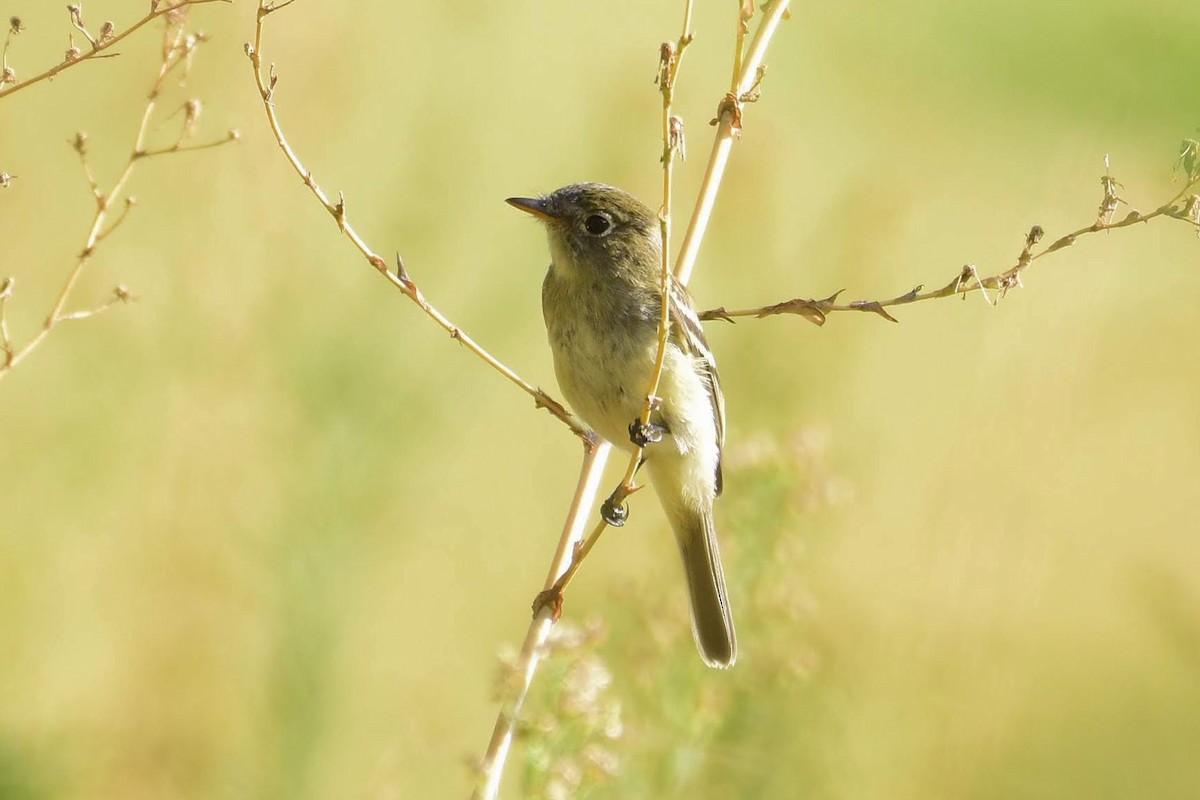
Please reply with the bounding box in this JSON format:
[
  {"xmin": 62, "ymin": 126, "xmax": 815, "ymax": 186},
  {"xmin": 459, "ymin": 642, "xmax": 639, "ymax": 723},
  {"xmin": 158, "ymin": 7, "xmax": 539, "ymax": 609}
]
[{"xmin": 0, "ymin": 0, "xmax": 1200, "ymax": 799}]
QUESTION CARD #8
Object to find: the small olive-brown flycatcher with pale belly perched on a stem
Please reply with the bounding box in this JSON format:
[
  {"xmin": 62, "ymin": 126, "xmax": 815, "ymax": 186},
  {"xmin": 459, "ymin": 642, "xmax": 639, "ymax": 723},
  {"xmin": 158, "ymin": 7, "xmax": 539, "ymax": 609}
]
[{"xmin": 508, "ymin": 184, "xmax": 737, "ymax": 668}]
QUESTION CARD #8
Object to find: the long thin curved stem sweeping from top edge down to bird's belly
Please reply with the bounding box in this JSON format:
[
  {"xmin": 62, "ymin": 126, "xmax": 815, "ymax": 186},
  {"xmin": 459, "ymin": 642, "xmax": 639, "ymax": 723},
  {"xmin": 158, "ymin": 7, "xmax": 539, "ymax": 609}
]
[{"xmin": 246, "ymin": 0, "xmax": 592, "ymax": 444}]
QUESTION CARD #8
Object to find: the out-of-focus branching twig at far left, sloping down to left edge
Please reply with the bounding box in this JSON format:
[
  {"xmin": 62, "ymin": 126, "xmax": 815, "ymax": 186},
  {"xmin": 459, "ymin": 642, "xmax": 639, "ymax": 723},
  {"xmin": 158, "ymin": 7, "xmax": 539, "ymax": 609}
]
[{"xmin": 0, "ymin": 16, "xmax": 223, "ymax": 379}]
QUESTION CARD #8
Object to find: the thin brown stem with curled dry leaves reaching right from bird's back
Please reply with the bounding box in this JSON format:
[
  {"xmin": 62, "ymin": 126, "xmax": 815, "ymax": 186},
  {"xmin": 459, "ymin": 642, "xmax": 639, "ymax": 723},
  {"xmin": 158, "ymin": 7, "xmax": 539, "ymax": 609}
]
[{"xmin": 700, "ymin": 172, "xmax": 1200, "ymax": 325}]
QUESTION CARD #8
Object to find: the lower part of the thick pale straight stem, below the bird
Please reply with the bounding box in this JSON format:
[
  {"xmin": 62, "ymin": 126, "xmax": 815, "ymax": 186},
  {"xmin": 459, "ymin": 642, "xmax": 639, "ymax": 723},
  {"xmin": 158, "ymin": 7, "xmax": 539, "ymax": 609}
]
[{"xmin": 472, "ymin": 441, "xmax": 612, "ymax": 800}]
